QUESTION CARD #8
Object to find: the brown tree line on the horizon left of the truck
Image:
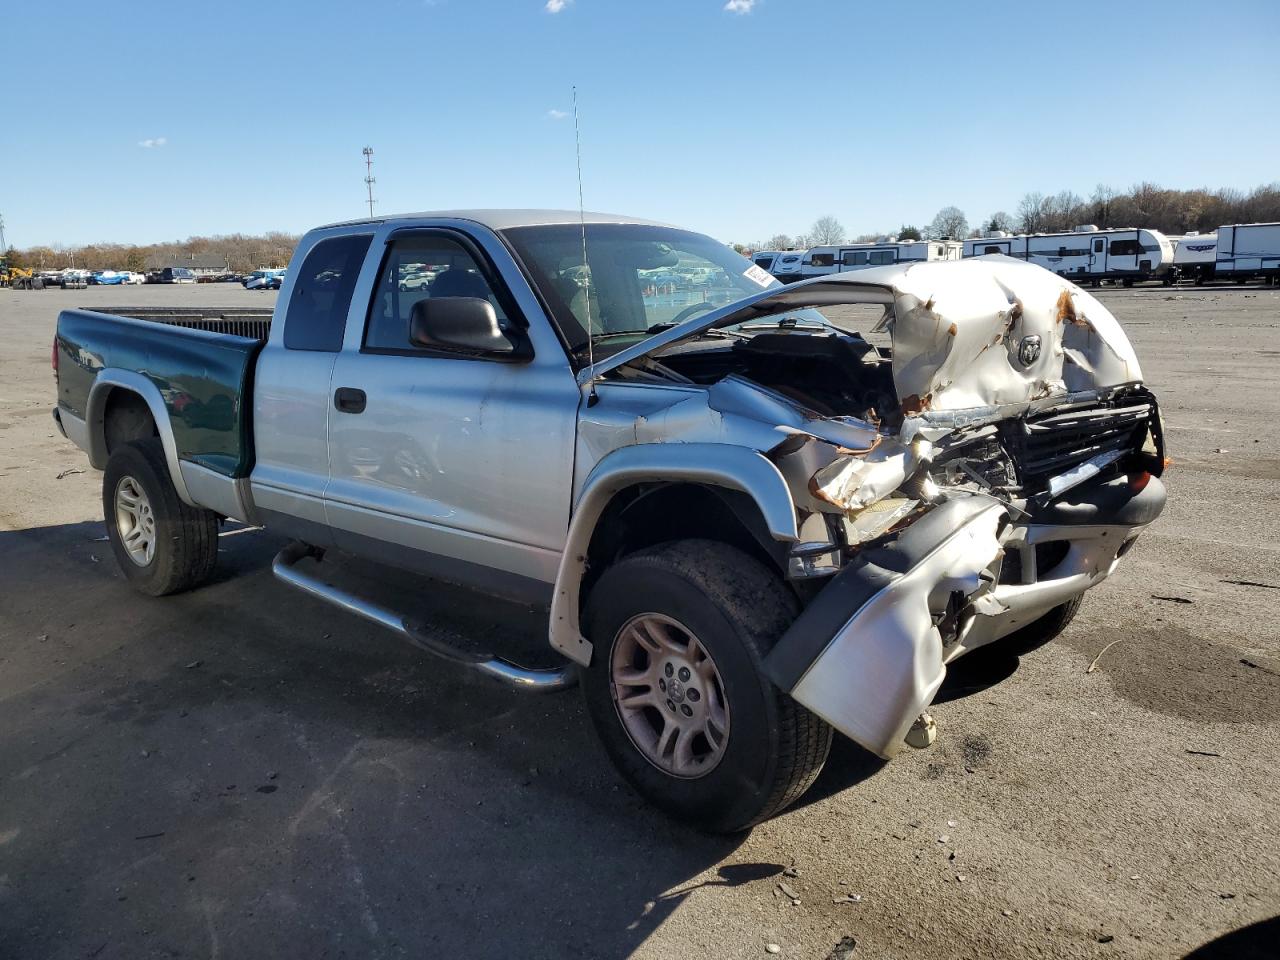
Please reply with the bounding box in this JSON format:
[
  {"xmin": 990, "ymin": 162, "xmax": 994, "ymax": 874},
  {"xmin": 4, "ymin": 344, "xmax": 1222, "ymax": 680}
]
[{"xmin": 8, "ymin": 232, "xmax": 300, "ymax": 273}]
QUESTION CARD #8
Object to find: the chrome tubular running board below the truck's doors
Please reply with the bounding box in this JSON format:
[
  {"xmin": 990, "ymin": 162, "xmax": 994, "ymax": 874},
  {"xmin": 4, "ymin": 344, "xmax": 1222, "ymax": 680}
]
[{"xmin": 271, "ymin": 543, "xmax": 577, "ymax": 692}]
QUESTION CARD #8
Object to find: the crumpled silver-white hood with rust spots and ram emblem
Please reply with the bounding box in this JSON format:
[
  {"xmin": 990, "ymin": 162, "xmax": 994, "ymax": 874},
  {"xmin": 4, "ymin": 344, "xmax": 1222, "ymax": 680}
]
[{"xmin": 579, "ymin": 255, "xmax": 1142, "ymax": 415}]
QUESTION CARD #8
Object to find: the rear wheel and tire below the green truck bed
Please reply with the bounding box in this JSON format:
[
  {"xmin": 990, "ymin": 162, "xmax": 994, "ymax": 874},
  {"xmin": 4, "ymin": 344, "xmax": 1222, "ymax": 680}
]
[{"xmin": 102, "ymin": 436, "xmax": 218, "ymax": 596}]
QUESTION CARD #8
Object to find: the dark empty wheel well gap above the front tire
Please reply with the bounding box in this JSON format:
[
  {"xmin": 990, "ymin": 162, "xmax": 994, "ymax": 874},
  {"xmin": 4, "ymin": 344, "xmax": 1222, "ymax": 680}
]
[{"xmin": 581, "ymin": 483, "xmax": 787, "ymax": 598}]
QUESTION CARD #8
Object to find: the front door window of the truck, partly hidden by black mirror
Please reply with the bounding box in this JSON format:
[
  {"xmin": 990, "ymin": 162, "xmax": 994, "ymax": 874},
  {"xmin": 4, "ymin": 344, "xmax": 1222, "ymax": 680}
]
[{"xmin": 365, "ymin": 234, "xmax": 511, "ymax": 352}]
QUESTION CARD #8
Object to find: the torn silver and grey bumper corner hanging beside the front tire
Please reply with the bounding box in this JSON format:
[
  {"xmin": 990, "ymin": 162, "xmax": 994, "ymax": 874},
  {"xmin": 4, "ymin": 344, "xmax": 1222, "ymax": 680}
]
[{"xmin": 764, "ymin": 497, "xmax": 1009, "ymax": 758}]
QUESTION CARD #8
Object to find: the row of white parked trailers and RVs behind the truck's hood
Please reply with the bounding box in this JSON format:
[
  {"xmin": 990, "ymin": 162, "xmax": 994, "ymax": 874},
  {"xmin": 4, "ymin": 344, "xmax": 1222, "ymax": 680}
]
[{"xmin": 753, "ymin": 223, "xmax": 1280, "ymax": 285}]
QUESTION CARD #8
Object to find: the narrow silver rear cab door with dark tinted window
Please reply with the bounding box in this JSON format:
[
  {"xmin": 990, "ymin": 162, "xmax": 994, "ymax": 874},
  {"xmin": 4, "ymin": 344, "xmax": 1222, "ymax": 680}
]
[{"xmin": 251, "ymin": 234, "xmax": 372, "ymax": 545}]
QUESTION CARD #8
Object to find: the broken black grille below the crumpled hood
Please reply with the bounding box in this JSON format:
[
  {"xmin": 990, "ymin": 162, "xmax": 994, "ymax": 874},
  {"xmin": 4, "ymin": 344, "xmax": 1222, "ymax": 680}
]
[{"xmin": 1000, "ymin": 401, "xmax": 1151, "ymax": 493}]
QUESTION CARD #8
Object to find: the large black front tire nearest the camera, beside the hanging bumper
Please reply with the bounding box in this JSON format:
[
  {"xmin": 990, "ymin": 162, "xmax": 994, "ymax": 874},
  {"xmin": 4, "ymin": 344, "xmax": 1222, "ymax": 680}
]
[{"xmin": 582, "ymin": 540, "xmax": 832, "ymax": 833}]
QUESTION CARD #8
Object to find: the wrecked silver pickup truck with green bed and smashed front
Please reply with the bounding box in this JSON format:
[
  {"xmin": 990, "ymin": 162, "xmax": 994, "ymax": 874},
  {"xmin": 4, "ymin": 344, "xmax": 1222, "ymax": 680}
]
[{"xmin": 54, "ymin": 210, "xmax": 1165, "ymax": 831}]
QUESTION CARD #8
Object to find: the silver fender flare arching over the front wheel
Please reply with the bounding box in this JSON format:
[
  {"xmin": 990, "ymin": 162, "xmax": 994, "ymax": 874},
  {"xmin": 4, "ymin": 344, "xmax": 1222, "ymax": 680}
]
[{"xmin": 549, "ymin": 443, "xmax": 800, "ymax": 667}]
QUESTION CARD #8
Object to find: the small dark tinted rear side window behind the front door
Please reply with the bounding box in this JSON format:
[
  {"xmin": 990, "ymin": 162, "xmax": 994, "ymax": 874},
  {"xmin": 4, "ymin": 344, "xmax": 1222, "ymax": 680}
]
[{"xmin": 284, "ymin": 234, "xmax": 371, "ymax": 353}]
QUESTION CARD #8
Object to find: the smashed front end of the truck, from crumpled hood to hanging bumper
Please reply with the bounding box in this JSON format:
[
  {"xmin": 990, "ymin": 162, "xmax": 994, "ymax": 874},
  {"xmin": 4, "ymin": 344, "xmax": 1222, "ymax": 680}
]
[{"xmin": 576, "ymin": 257, "xmax": 1165, "ymax": 756}]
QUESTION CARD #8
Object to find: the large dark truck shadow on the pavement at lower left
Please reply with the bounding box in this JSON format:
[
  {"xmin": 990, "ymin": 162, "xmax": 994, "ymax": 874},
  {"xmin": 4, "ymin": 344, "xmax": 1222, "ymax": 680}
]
[{"xmin": 0, "ymin": 524, "xmax": 782, "ymax": 960}]
